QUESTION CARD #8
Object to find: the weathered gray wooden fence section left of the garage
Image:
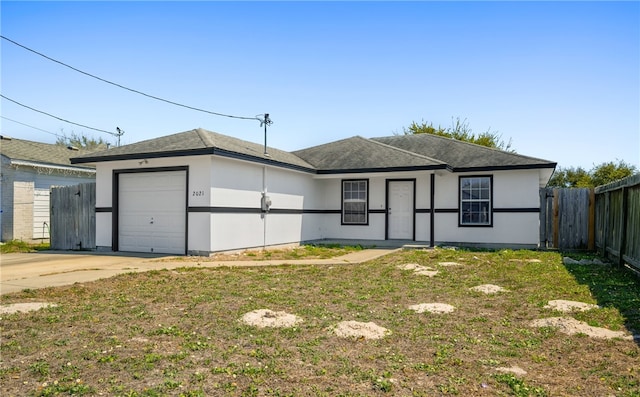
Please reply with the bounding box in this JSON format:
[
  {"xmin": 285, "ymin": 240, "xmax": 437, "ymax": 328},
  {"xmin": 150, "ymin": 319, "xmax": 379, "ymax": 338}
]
[{"xmin": 50, "ymin": 183, "xmax": 96, "ymax": 250}]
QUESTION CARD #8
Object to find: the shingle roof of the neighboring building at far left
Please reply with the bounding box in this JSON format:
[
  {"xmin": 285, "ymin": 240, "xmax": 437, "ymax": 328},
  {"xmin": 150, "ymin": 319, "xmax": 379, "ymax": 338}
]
[{"xmin": 0, "ymin": 136, "xmax": 94, "ymax": 169}]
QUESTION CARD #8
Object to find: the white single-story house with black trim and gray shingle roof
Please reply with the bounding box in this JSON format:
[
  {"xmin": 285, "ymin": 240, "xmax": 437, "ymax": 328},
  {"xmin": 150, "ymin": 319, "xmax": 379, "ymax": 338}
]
[{"xmin": 72, "ymin": 129, "xmax": 556, "ymax": 255}]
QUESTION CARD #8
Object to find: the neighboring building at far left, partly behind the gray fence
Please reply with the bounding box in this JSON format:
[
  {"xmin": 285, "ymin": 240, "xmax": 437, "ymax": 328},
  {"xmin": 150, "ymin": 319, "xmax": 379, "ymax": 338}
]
[{"xmin": 0, "ymin": 136, "xmax": 96, "ymax": 241}]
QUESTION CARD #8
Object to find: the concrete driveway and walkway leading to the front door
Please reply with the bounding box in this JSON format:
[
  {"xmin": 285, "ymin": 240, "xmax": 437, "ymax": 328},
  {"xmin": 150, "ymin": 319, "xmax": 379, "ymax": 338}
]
[{"xmin": 0, "ymin": 247, "xmax": 398, "ymax": 294}]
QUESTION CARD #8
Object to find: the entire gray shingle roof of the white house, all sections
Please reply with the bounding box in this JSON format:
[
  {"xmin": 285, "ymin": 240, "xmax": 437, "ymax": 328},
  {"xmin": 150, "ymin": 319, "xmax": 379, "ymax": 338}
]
[{"xmin": 71, "ymin": 128, "xmax": 556, "ymax": 174}]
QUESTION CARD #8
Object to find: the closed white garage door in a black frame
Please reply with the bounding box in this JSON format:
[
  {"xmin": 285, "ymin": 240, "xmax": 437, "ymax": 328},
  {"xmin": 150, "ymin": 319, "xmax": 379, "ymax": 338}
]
[{"xmin": 118, "ymin": 171, "xmax": 187, "ymax": 254}]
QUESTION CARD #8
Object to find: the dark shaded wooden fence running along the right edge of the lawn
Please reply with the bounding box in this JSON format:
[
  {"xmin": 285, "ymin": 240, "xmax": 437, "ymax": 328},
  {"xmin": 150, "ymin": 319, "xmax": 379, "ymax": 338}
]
[{"xmin": 595, "ymin": 174, "xmax": 640, "ymax": 271}]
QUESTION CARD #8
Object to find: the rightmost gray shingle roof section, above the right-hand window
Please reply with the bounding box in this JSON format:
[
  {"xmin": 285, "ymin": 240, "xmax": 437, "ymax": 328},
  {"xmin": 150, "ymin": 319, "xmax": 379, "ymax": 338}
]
[{"xmin": 372, "ymin": 134, "xmax": 556, "ymax": 171}]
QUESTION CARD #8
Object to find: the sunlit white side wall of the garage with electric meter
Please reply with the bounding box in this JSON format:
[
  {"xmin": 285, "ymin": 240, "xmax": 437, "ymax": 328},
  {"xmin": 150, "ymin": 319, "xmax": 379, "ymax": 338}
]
[{"xmin": 210, "ymin": 157, "xmax": 319, "ymax": 251}]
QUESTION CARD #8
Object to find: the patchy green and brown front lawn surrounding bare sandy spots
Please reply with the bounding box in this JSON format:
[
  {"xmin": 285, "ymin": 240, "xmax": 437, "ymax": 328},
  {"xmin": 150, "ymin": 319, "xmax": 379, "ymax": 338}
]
[{"xmin": 0, "ymin": 249, "xmax": 640, "ymax": 396}]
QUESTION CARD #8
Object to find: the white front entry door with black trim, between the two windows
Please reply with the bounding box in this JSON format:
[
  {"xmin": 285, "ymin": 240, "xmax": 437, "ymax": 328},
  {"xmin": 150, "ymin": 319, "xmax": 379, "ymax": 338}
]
[{"xmin": 387, "ymin": 181, "xmax": 414, "ymax": 240}]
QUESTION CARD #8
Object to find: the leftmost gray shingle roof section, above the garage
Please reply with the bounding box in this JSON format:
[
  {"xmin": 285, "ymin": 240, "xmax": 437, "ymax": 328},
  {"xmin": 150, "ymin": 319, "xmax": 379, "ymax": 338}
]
[{"xmin": 72, "ymin": 128, "xmax": 313, "ymax": 170}]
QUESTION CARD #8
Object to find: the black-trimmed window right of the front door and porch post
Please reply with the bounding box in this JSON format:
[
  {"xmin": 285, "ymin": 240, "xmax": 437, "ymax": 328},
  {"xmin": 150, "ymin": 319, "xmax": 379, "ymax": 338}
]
[{"xmin": 460, "ymin": 176, "xmax": 493, "ymax": 226}]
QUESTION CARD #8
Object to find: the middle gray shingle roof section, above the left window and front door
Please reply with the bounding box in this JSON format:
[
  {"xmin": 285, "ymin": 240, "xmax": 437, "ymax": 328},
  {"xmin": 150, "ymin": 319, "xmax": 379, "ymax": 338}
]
[{"xmin": 293, "ymin": 136, "xmax": 447, "ymax": 172}]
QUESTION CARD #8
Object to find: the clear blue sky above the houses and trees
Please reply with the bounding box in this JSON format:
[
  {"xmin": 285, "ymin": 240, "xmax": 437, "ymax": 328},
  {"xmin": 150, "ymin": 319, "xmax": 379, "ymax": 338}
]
[{"xmin": 0, "ymin": 1, "xmax": 640, "ymax": 170}]
